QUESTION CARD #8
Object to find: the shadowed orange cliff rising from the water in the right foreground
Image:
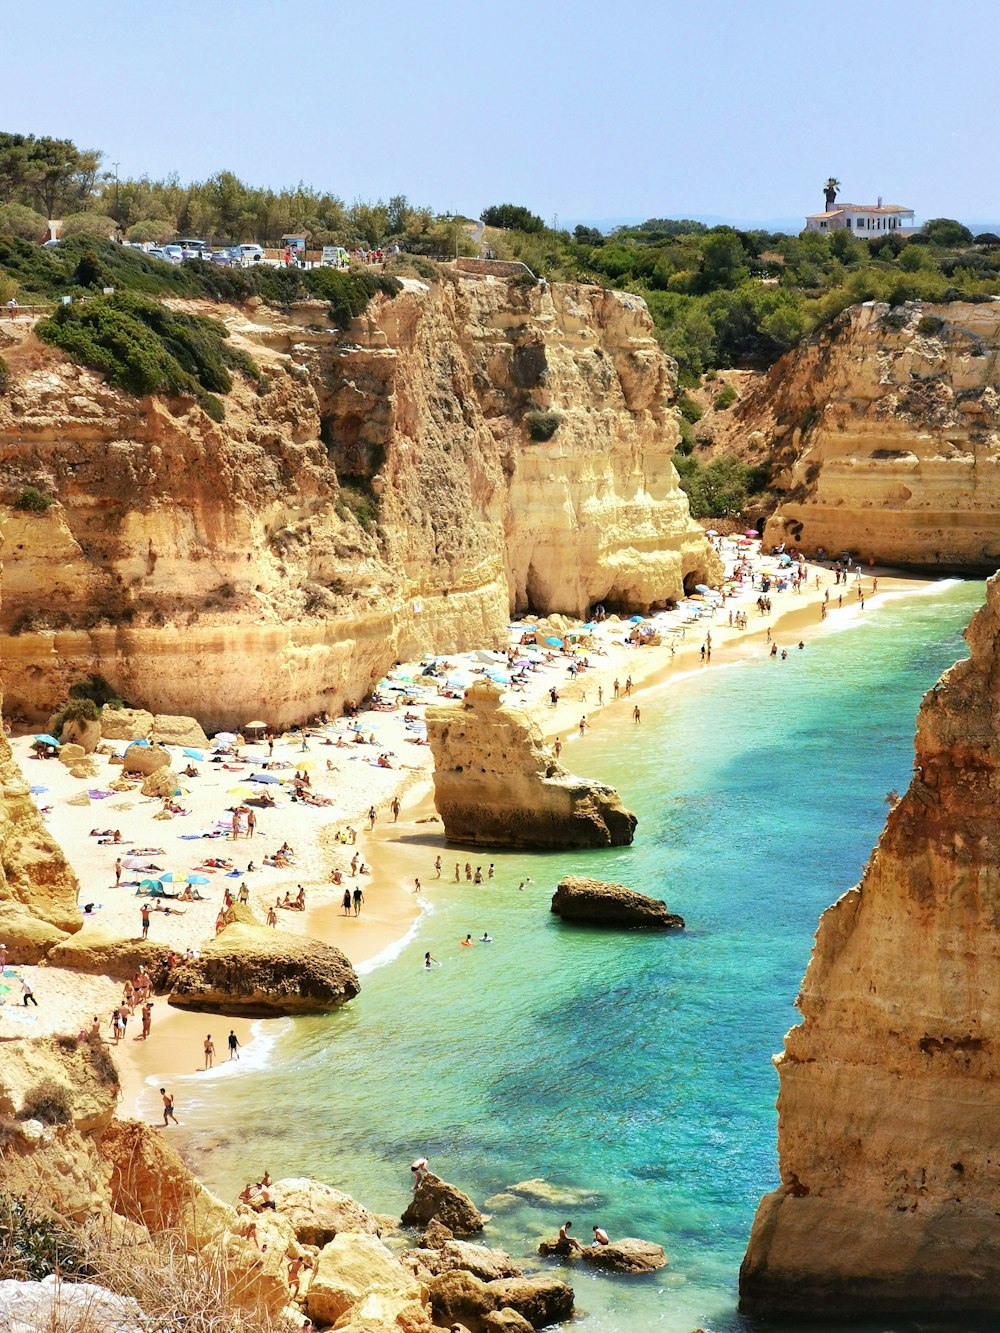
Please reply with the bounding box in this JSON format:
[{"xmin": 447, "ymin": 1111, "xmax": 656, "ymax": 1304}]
[{"xmin": 741, "ymin": 577, "xmax": 1000, "ymax": 1316}]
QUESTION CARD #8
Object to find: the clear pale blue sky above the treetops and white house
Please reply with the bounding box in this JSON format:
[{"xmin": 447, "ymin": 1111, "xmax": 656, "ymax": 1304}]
[{"xmin": 7, "ymin": 0, "xmax": 1000, "ymax": 221}]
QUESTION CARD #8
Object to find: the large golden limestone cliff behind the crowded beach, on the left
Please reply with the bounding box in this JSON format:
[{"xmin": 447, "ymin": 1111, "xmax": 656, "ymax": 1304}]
[{"xmin": 0, "ymin": 271, "xmax": 717, "ymax": 726}]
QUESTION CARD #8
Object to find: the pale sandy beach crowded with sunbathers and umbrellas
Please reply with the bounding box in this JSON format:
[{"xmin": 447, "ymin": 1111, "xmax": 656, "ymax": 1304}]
[{"xmin": 0, "ymin": 540, "xmax": 928, "ymax": 1122}]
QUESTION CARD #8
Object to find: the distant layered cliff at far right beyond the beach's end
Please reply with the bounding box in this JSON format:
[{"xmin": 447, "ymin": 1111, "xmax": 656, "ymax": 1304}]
[{"xmin": 731, "ymin": 301, "xmax": 1000, "ymax": 573}]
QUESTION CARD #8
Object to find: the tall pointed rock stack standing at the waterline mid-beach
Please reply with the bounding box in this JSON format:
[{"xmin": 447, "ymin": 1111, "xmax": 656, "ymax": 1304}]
[{"xmin": 427, "ymin": 681, "xmax": 637, "ymax": 848}]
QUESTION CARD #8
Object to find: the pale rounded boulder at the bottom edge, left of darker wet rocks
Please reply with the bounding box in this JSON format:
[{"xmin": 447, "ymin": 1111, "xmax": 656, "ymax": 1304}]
[{"xmin": 305, "ymin": 1232, "xmax": 424, "ymax": 1325}]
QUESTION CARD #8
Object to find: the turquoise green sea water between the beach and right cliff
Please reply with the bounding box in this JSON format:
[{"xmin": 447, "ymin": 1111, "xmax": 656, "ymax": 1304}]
[{"xmin": 179, "ymin": 583, "xmax": 983, "ymax": 1333}]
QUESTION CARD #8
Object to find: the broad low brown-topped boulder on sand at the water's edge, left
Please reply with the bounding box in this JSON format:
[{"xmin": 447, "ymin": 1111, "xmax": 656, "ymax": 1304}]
[{"xmin": 169, "ymin": 921, "xmax": 361, "ymax": 1017}]
